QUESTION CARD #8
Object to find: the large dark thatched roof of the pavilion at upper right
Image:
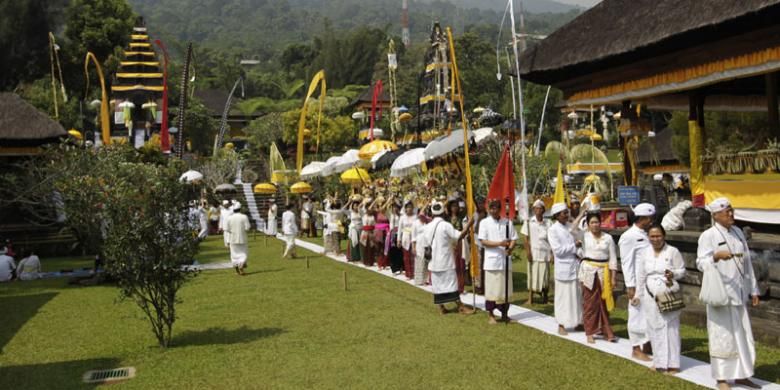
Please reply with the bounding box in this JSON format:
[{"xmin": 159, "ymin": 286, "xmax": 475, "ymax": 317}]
[{"xmin": 521, "ymin": 0, "xmax": 780, "ymax": 84}]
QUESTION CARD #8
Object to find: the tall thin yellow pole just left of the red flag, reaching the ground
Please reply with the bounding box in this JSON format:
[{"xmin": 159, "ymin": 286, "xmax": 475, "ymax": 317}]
[{"xmin": 447, "ymin": 27, "xmax": 480, "ymax": 288}]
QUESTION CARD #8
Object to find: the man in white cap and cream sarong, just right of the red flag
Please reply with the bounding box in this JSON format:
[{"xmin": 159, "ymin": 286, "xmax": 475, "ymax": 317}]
[{"xmin": 520, "ymin": 199, "xmax": 553, "ymax": 303}]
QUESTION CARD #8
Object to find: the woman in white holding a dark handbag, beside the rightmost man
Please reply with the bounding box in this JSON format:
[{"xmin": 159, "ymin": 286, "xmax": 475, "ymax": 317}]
[{"xmin": 636, "ymin": 225, "xmax": 685, "ymax": 374}]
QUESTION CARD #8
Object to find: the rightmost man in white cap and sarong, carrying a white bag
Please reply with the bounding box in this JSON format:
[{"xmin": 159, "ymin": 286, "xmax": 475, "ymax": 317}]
[{"xmin": 696, "ymin": 198, "xmax": 760, "ymax": 389}]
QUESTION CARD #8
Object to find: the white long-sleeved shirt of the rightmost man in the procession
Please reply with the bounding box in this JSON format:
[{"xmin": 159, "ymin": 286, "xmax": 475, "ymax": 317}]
[{"xmin": 696, "ymin": 223, "xmax": 759, "ymax": 306}]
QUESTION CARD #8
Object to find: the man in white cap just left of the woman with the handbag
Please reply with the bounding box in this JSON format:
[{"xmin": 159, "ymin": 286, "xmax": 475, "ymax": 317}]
[{"xmin": 618, "ymin": 203, "xmax": 655, "ymax": 362}]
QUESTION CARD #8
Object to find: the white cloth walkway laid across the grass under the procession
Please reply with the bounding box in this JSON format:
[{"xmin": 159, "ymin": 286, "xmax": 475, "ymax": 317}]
[{"xmin": 288, "ymin": 239, "xmax": 780, "ymax": 390}]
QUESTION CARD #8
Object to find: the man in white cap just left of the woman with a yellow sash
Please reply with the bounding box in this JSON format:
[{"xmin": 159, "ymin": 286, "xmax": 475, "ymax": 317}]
[{"xmin": 547, "ymin": 203, "xmax": 582, "ymax": 336}]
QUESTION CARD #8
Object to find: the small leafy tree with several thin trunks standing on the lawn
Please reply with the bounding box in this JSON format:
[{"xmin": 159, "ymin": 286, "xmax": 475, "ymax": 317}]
[{"xmin": 103, "ymin": 158, "xmax": 197, "ymax": 348}]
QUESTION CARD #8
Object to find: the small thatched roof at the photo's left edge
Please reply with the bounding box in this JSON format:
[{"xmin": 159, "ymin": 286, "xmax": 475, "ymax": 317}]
[{"xmin": 0, "ymin": 92, "xmax": 67, "ymax": 142}]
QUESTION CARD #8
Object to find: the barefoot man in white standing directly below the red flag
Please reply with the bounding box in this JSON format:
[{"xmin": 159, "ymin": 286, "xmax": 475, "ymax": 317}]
[{"xmin": 477, "ymin": 199, "xmax": 517, "ymax": 324}]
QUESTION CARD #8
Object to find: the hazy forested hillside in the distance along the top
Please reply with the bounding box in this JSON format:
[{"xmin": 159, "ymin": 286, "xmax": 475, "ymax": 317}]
[{"xmin": 129, "ymin": 0, "xmax": 581, "ymax": 57}]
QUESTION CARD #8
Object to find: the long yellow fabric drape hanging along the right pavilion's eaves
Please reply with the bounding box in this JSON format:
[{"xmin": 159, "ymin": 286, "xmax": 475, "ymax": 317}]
[{"xmin": 568, "ymin": 47, "xmax": 780, "ymax": 103}]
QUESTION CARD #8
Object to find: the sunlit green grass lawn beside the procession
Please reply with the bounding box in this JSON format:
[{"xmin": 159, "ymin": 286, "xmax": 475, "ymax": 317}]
[{"xmin": 0, "ymin": 236, "xmax": 780, "ymax": 389}]
